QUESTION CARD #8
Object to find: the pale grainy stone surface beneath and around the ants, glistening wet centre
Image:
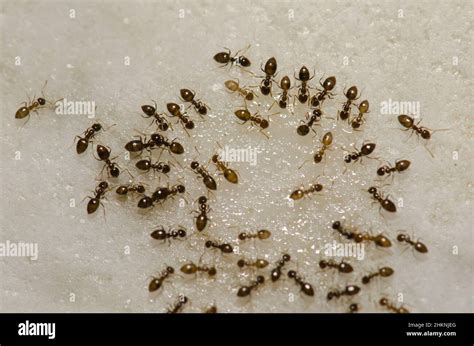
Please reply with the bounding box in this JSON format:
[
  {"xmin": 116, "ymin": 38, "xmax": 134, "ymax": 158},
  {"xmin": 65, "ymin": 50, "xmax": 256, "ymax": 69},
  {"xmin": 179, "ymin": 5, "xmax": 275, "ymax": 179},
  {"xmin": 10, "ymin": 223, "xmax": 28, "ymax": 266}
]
[{"xmin": 0, "ymin": 1, "xmax": 473, "ymax": 312}]
